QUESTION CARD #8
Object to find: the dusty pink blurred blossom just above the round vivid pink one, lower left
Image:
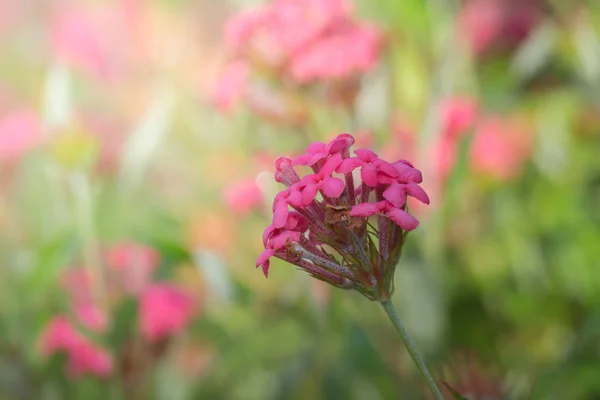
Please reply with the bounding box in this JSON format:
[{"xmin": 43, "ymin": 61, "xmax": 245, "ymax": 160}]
[{"xmin": 106, "ymin": 242, "xmax": 161, "ymax": 295}]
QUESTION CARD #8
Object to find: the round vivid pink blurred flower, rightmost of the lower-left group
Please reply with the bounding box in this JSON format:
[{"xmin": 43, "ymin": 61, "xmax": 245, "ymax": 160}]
[{"xmin": 140, "ymin": 283, "xmax": 195, "ymax": 342}]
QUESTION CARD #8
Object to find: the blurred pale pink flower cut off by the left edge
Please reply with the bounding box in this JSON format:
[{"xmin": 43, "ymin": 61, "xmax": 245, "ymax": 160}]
[{"xmin": 0, "ymin": 109, "xmax": 42, "ymax": 160}]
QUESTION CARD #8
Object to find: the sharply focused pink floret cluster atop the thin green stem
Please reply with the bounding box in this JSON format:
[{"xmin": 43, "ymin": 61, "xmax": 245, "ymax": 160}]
[{"xmin": 256, "ymin": 134, "xmax": 429, "ymax": 300}]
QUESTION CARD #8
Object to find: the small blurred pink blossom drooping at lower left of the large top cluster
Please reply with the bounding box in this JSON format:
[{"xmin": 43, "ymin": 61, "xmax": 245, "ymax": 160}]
[{"xmin": 213, "ymin": 61, "xmax": 250, "ymax": 112}]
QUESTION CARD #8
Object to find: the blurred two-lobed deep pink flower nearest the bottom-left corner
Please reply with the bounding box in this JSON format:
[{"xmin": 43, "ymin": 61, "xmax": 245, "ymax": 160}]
[{"xmin": 40, "ymin": 315, "xmax": 112, "ymax": 378}]
